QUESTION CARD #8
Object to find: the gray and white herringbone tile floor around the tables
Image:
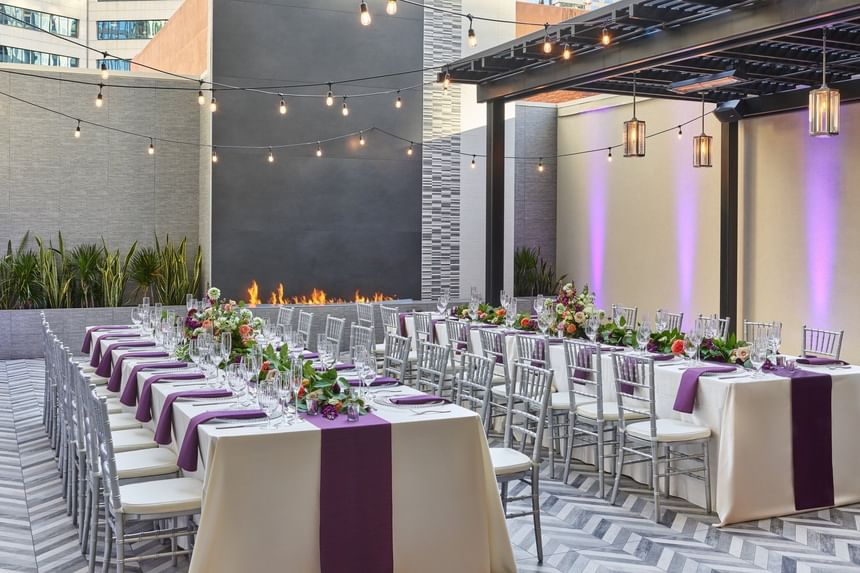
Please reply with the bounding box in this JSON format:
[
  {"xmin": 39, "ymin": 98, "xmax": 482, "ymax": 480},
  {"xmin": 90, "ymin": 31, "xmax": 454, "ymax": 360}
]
[{"xmin": 0, "ymin": 360, "xmax": 860, "ymax": 573}]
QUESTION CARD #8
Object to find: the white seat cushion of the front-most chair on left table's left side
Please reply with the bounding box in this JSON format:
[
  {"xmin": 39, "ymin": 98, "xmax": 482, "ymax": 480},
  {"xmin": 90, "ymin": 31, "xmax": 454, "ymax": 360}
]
[{"xmin": 119, "ymin": 478, "xmax": 203, "ymax": 515}]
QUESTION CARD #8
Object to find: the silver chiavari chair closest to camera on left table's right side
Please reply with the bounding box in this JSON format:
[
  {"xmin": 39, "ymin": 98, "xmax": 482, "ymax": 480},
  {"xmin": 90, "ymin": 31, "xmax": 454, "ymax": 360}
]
[{"xmin": 490, "ymin": 362, "xmax": 552, "ymax": 563}]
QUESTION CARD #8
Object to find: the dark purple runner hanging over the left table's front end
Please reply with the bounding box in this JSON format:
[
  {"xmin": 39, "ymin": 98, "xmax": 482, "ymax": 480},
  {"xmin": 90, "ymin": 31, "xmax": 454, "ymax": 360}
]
[{"xmin": 305, "ymin": 414, "xmax": 394, "ymax": 573}]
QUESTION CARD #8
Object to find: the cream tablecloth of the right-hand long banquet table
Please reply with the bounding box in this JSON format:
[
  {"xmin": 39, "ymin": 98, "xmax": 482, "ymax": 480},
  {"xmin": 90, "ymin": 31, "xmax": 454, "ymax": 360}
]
[{"xmin": 405, "ymin": 316, "xmax": 860, "ymax": 525}]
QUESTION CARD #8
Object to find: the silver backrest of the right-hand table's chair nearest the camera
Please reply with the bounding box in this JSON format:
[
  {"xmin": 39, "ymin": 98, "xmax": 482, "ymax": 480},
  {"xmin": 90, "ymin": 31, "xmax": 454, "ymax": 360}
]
[{"xmin": 612, "ymin": 352, "xmax": 657, "ymax": 440}]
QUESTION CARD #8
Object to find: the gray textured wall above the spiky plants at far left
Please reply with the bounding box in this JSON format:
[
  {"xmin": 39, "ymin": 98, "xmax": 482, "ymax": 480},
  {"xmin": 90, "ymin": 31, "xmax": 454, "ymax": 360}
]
[{"xmin": 0, "ymin": 64, "xmax": 200, "ymax": 252}]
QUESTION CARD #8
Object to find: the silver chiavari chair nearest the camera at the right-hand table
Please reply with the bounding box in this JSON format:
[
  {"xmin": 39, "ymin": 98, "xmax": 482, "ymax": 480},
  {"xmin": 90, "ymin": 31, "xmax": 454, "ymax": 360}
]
[{"xmin": 610, "ymin": 353, "xmax": 711, "ymax": 522}]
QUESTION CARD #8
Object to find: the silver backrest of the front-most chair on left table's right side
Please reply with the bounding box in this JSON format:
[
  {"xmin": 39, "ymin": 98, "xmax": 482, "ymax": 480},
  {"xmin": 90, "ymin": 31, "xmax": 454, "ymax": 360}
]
[{"xmin": 505, "ymin": 362, "xmax": 552, "ymax": 464}]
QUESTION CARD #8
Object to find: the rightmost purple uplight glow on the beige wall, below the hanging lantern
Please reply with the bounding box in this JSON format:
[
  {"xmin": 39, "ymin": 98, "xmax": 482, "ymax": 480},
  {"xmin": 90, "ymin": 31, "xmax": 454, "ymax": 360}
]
[{"xmin": 798, "ymin": 121, "xmax": 842, "ymax": 327}]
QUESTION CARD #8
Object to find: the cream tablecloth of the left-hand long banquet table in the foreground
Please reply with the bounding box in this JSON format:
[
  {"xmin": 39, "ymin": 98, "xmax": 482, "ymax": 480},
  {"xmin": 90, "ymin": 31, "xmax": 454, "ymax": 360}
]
[{"xmin": 92, "ymin": 326, "xmax": 516, "ymax": 573}]
